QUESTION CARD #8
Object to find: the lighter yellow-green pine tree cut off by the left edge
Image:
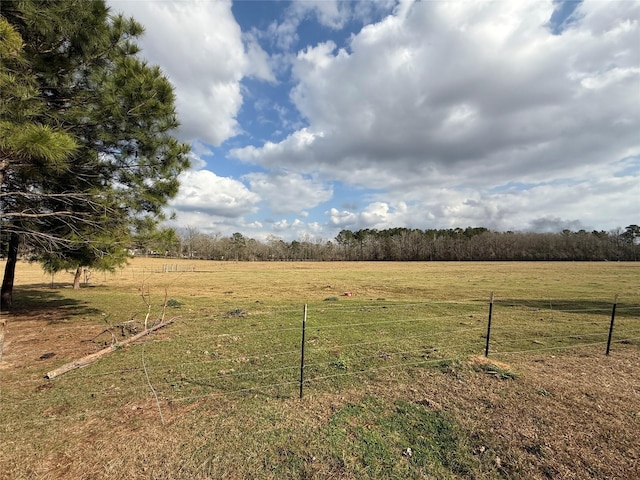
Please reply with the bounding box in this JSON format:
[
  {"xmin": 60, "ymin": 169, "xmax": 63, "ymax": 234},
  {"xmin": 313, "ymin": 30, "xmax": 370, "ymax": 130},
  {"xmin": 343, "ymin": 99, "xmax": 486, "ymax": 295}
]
[{"xmin": 0, "ymin": 17, "xmax": 78, "ymax": 308}]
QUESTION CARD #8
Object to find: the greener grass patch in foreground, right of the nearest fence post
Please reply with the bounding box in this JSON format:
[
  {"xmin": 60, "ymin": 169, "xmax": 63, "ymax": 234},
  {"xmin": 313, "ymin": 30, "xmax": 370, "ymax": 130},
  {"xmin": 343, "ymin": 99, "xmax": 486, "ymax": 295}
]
[{"xmin": 325, "ymin": 397, "xmax": 490, "ymax": 479}]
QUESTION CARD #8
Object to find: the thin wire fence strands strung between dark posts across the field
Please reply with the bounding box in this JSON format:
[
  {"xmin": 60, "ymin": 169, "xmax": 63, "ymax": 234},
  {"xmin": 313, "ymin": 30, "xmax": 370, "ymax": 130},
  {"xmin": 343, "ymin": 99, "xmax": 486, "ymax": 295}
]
[{"xmin": 4, "ymin": 301, "xmax": 640, "ymax": 428}]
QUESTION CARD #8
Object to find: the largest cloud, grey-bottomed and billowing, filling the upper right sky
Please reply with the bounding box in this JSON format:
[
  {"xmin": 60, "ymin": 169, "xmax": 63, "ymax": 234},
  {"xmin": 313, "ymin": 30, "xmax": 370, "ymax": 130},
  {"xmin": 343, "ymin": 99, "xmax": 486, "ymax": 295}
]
[{"xmin": 233, "ymin": 0, "xmax": 640, "ymax": 189}]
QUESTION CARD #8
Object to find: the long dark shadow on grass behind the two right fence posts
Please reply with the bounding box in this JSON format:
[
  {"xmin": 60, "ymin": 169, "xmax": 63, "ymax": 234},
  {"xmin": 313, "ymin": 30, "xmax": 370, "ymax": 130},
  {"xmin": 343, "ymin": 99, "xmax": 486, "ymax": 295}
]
[{"xmin": 495, "ymin": 298, "xmax": 640, "ymax": 318}]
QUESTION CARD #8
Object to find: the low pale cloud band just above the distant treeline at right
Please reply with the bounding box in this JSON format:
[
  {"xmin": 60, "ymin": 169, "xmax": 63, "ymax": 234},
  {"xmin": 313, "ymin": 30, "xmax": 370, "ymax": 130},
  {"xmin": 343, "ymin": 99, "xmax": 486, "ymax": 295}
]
[{"xmin": 358, "ymin": 172, "xmax": 640, "ymax": 231}]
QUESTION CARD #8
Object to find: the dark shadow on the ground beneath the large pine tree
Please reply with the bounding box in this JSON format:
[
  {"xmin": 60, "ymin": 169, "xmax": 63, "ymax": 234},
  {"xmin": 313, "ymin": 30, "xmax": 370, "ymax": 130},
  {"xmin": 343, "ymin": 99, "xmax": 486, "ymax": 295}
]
[{"xmin": 7, "ymin": 284, "xmax": 100, "ymax": 323}]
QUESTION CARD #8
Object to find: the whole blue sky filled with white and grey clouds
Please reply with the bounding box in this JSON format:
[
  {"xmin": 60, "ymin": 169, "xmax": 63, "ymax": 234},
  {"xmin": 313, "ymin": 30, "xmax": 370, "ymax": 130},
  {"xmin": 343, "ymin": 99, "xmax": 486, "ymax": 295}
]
[{"xmin": 108, "ymin": 0, "xmax": 640, "ymax": 241}]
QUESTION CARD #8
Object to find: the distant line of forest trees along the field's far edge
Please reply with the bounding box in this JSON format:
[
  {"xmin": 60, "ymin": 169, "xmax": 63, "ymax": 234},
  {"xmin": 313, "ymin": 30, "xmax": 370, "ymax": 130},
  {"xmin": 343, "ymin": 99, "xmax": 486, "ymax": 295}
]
[{"xmin": 166, "ymin": 225, "xmax": 640, "ymax": 261}]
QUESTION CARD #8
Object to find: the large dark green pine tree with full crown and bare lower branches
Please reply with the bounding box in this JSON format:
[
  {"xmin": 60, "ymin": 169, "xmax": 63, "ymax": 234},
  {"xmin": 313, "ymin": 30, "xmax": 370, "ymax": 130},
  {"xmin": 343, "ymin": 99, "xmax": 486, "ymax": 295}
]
[{"xmin": 0, "ymin": 0, "xmax": 189, "ymax": 307}]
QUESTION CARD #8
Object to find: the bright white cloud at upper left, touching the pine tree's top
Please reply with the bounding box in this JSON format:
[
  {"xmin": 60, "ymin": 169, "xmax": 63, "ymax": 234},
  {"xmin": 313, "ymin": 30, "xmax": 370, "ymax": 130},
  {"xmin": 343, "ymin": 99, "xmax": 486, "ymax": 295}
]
[{"xmin": 109, "ymin": 0, "xmax": 274, "ymax": 145}]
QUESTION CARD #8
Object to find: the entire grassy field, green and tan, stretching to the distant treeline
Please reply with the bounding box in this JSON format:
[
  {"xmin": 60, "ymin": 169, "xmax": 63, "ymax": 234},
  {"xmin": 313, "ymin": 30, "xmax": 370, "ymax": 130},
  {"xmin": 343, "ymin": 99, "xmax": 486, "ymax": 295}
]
[{"xmin": 0, "ymin": 259, "xmax": 640, "ymax": 479}]
